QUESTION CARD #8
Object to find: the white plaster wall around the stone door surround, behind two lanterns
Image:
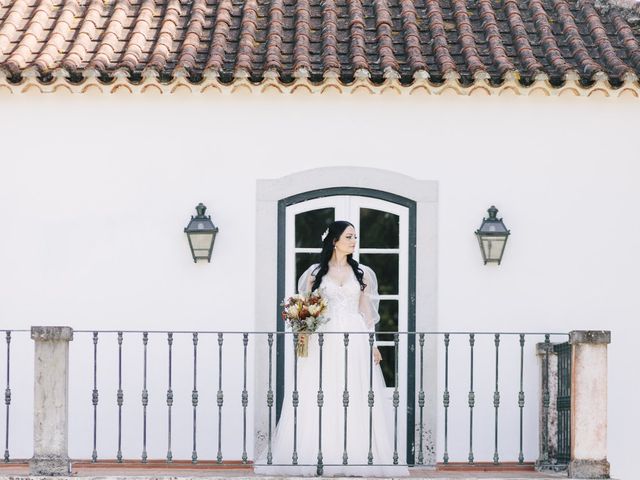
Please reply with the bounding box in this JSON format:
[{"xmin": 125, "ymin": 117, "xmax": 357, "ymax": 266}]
[{"xmin": 0, "ymin": 95, "xmax": 640, "ymax": 478}]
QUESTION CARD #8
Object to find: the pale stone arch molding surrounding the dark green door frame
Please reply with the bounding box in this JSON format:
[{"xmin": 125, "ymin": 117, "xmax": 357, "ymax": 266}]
[{"xmin": 254, "ymin": 166, "xmax": 438, "ymax": 463}]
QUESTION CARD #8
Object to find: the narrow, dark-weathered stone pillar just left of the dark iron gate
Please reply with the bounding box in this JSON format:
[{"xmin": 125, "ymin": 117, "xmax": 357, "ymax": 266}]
[{"xmin": 536, "ymin": 342, "xmax": 558, "ymax": 471}]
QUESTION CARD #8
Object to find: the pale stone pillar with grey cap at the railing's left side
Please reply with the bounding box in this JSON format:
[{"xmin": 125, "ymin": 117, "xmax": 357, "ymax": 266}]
[{"xmin": 29, "ymin": 327, "xmax": 73, "ymax": 476}]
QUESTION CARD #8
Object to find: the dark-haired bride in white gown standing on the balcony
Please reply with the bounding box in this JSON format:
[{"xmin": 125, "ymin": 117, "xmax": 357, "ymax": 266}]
[{"xmin": 255, "ymin": 221, "xmax": 409, "ymax": 477}]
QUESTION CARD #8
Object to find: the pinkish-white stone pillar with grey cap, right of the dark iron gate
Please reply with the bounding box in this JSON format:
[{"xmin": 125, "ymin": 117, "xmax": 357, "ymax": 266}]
[{"xmin": 569, "ymin": 330, "xmax": 611, "ymax": 478}]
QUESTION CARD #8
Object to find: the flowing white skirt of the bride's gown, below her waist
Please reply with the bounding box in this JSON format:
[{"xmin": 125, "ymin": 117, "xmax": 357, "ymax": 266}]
[{"xmin": 255, "ymin": 315, "xmax": 409, "ymax": 477}]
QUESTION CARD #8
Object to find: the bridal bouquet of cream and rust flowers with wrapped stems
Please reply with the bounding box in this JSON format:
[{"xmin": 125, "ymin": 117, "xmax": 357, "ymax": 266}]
[{"xmin": 281, "ymin": 290, "xmax": 329, "ymax": 357}]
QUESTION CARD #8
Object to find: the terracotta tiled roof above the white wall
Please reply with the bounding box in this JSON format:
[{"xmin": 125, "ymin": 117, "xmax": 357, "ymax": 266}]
[{"xmin": 0, "ymin": 0, "xmax": 640, "ymax": 85}]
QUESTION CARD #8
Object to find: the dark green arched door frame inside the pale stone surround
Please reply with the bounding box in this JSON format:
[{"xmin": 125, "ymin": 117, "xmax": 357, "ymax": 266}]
[{"xmin": 275, "ymin": 187, "xmax": 416, "ymax": 465}]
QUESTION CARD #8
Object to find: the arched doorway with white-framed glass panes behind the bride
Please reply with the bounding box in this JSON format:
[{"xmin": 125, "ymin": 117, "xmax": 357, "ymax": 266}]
[{"xmin": 276, "ymin": 187, "xmax": 416, "ymax": 463}]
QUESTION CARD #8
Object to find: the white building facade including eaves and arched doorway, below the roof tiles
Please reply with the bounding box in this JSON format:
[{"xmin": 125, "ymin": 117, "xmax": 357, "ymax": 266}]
[{"xmin": 0, "ymin": 2, "xmax": 640, "ymax": 479}]
